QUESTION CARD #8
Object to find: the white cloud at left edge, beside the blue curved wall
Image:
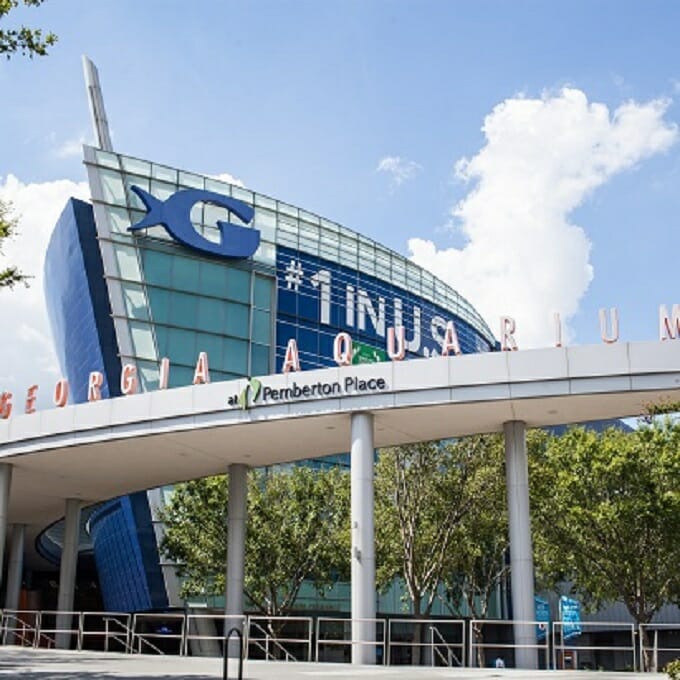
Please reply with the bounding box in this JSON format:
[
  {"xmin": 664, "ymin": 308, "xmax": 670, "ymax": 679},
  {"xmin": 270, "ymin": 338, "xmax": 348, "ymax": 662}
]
[{"xmin": 0, "ymin": 175, "xmax": 89, "ymax": 409}]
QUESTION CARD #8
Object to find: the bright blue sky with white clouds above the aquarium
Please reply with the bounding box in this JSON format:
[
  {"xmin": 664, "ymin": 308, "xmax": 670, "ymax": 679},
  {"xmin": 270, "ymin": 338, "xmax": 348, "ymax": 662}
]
[{"xmin": 0, "ymin": 0, "xmax": 680, "ymax": 390}]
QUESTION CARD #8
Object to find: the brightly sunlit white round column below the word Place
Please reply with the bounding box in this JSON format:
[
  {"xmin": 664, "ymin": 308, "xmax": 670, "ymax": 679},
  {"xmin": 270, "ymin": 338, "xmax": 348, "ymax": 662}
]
[{"xmin": 351, "ymin": 413, "xmax": 376, "ymax": 664}]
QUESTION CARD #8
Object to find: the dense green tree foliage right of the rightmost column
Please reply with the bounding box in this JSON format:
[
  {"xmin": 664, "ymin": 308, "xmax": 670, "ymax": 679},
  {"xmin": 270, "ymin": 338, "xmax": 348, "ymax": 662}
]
[{"xmin": 530, "ymin": 420, "xmax": 680, "ymax": 623}]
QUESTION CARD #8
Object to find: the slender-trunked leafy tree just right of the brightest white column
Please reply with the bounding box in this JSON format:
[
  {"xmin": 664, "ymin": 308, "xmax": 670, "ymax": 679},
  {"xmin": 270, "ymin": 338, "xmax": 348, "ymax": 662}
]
[{"xmin": 375, "ymin": 438, "xmax": 492, "ymax": 663}]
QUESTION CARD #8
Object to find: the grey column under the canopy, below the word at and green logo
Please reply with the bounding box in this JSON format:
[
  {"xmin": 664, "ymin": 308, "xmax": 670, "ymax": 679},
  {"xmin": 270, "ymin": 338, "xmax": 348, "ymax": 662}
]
[{"xmin": 224, "ymin": 464, "xmax": 248, "ymax": 677}]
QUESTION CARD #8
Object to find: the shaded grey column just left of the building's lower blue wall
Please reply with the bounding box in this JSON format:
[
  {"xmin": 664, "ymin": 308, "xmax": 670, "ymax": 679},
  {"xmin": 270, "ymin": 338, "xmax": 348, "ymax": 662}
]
[{"xmin": 55, "ymin": 498, "xmax": 82, "ymax": 649}]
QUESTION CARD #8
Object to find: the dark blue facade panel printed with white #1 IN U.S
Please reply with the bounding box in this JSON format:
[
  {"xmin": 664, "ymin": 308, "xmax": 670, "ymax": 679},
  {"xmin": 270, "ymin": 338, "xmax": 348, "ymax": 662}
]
[{"xmin": 276, "ymin": 246, "xmax": 492, "ymax": 369}]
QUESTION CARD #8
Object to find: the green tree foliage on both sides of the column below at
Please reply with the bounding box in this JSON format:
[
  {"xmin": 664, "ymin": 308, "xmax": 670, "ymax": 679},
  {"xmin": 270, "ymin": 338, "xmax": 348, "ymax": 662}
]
[{"xmin": 162, "ymin": 466, "xmax": 350, "ymax": 616}]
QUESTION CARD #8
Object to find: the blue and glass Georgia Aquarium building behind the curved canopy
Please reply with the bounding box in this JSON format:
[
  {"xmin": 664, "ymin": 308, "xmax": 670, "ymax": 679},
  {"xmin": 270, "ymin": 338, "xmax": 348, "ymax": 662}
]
[{"xmin": 45, "ymin": 147, "xmax": 496, "ymax": 611}]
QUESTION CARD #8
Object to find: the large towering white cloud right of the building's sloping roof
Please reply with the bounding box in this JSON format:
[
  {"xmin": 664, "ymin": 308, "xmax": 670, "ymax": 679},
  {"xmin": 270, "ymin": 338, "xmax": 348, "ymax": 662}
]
[{"xmin": 409, "ymin": 88, "xmax": 678, "ymax": 347}]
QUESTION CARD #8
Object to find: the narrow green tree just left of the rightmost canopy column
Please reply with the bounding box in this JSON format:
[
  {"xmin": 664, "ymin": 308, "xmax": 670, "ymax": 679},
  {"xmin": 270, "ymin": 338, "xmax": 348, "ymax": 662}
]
[{"xmin": 442, "ymin": 435, "xmax": 510, "ymax": 668}]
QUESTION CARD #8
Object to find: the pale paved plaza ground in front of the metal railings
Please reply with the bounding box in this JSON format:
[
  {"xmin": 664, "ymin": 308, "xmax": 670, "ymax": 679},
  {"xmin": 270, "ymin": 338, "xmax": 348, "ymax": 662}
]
[{"xmin": 0, "ymin": 646, "xmax": 666, "ymax": 680}]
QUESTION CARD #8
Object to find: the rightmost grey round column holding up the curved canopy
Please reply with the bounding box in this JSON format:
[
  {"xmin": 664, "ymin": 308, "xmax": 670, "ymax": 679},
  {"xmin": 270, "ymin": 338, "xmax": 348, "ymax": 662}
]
[{"xmin": 503, "ymin": 421, "xmax": 538, "ymax": 669}]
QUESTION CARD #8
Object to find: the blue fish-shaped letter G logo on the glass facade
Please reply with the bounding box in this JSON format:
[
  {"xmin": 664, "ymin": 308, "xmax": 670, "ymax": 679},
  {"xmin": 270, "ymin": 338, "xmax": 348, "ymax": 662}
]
[{"xmin": 128, "ymin": 186, "xmax": 260, "ymax": 258}]
